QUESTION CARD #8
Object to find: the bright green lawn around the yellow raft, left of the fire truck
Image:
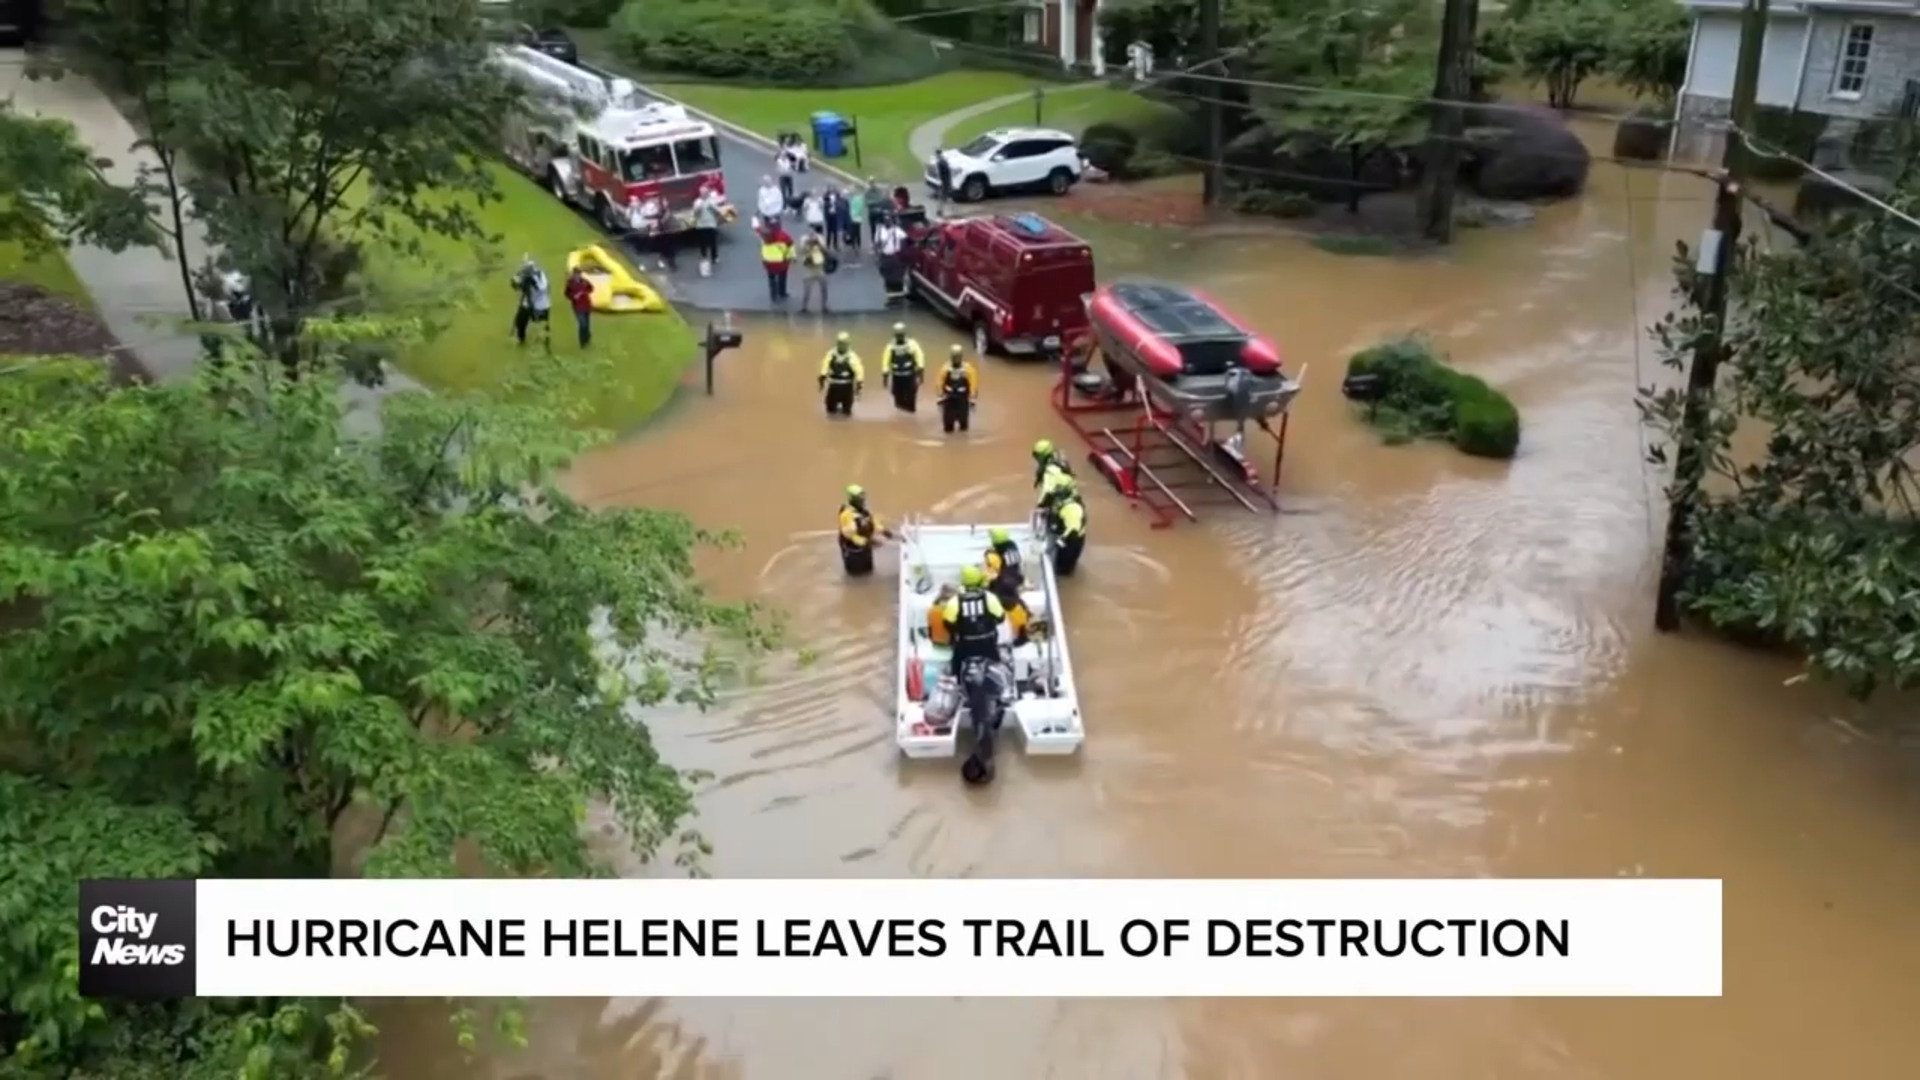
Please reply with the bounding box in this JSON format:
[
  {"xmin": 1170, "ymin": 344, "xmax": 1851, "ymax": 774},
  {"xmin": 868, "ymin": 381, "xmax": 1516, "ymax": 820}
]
[{"xmin": 351, "ymin": 167, "xmax": 697, "ymax": 432}]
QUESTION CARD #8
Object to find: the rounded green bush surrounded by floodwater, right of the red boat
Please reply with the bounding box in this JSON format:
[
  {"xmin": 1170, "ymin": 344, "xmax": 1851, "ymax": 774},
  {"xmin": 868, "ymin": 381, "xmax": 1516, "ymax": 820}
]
[{"xmin": 1346, "ymin": 338, "xmax": 1521, "ymax": 457}]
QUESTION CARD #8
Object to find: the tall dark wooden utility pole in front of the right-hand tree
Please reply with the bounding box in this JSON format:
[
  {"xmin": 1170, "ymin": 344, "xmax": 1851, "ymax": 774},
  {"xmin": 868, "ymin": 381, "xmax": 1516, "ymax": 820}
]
[{"xmin": 1636, "ymin": 0, "xmax": 1766, "ymax": 632}]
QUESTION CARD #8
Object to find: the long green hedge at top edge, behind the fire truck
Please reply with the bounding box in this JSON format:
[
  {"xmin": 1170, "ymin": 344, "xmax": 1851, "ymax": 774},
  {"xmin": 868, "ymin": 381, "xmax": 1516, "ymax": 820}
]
[{"xmin": 612, "ymin": 0, "xmax": 854, "ymax": 83}]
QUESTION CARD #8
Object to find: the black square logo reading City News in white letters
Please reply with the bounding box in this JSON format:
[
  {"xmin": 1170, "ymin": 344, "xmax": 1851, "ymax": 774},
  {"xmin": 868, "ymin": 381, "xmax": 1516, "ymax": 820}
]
[{"xmin": 79, "ymin": 880, "xmax": 194, "ymax": 999}]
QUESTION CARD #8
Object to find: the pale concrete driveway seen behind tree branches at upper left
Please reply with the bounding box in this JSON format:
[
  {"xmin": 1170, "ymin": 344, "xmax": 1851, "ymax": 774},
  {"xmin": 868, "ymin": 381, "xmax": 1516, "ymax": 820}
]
[{"xmin": 0, "ymin": 50, "xmax": 205, "ymax": 380}]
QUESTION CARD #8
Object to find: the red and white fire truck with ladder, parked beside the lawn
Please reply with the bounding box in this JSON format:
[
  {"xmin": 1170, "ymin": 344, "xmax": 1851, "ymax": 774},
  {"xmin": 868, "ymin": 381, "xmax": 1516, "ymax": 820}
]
[{"xmin": 493, "ymin": 44, "xmax": 733, "ymax": 234}]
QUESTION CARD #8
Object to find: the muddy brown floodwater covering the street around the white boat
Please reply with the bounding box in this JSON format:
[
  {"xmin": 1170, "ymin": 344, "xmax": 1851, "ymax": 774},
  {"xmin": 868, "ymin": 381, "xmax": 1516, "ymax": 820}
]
[{"xmin": 378, "ymin": 138, "xmax": 1920, "ymax": 1080}]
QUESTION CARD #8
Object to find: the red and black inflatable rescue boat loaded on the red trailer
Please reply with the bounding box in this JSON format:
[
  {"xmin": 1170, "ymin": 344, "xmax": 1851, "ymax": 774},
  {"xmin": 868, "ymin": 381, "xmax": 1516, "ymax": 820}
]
[{"xmin": 1087, "ymin": 282, "xmax": 1300, "ymax": 421}]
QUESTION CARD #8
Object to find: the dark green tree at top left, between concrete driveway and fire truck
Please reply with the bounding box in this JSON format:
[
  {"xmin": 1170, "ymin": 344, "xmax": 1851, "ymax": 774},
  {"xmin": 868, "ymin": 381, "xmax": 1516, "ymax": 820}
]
[{"xmin": 61, "ymin": 0, "xmax": 515, "ymax": 359}]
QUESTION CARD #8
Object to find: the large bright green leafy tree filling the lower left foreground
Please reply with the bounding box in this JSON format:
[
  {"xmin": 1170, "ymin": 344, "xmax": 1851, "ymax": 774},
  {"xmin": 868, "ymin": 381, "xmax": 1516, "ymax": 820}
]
[{"xmin": 0, "ymin": 345, "xmax": 768, "ymax": 1080}]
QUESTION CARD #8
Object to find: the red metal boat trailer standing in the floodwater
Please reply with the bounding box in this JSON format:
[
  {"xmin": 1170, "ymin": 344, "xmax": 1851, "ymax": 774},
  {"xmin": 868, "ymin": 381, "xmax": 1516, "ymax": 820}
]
[{"xmin": 1052, "ymin": 332, "xmax": 1306, "ymax": 528}]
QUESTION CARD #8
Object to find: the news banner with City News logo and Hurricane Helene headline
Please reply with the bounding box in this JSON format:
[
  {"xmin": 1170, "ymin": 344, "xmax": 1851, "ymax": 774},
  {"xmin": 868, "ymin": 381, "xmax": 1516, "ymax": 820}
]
[{"xmin": 79, "ymin": 878, "xmax": 1720, "ymax": 999}]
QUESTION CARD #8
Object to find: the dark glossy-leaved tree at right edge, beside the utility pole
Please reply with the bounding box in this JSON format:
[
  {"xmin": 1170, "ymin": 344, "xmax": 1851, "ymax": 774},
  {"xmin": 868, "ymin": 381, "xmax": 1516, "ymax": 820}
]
[{"xmin": 1640, "ymin": 158, "xmax": 1920, "ymax": 696}]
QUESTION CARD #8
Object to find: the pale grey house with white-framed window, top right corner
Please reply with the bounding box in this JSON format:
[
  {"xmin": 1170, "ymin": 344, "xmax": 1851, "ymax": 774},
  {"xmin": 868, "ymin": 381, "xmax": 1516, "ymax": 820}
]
[{"xmin": 1680, "ymin": 0, "xmax": 1920, "ymax": 133}]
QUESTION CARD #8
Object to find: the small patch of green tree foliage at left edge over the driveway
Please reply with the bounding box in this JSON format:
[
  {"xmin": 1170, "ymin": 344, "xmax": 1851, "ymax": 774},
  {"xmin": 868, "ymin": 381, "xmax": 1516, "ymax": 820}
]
[{"xmin": 0, "ymin": 102, "xmax": 159, "ymax": 252}]
